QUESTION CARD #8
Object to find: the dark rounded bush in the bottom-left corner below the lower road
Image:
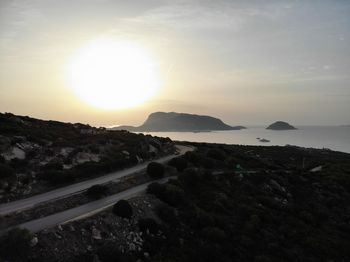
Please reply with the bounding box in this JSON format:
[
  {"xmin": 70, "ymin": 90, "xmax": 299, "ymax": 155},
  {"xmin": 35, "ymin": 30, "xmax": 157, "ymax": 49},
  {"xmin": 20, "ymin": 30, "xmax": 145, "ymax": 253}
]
[{"xmin": 0, "ymin": 228, "xmax": 33, "ymax": 261}]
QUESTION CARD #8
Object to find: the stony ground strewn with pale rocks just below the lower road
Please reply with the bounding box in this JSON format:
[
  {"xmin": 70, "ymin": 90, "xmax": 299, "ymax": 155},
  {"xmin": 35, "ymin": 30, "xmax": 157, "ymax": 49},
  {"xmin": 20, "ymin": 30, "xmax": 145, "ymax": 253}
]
[{"xmin": 28, "ymin": 195, "xmax": 162, "ymax": 261}]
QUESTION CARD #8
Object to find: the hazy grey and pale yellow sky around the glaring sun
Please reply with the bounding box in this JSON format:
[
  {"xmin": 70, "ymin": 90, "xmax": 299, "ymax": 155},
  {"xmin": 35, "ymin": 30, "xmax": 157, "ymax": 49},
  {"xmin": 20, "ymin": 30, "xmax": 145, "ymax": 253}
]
[{"xmin": 0, "ymin": 0, "xmax": 350, "ymax": 126}]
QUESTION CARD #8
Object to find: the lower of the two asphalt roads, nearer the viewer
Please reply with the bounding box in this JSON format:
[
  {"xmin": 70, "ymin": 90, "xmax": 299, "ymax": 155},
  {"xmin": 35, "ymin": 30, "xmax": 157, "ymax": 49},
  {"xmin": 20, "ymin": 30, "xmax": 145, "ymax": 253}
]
[{"xmin": 16, "ymin": 177, "xmax": 169, "ymax": 233}]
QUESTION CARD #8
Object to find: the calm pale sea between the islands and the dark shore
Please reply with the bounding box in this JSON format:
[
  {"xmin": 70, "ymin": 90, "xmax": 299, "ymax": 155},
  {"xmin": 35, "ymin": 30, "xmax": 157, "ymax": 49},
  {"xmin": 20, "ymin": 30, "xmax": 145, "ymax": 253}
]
[{"xmin": 142, "ymin": 126, "xmax": 350, "ymax": 153}]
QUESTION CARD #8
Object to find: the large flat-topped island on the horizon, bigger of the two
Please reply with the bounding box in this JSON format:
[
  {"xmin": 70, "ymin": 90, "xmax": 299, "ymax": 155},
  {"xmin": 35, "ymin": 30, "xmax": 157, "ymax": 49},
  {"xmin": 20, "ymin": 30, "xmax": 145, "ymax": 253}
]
[{"xmin": 113, "ymin": 112, "xmax": 245, "ymax": 132}]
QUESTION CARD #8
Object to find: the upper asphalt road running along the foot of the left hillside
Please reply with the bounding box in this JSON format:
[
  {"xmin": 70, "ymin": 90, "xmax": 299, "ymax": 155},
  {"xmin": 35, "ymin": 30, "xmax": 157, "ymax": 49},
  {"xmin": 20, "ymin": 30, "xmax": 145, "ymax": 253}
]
[{"xmin": 0, "ymin": 145, "xmax": 193, "ymax": 215}]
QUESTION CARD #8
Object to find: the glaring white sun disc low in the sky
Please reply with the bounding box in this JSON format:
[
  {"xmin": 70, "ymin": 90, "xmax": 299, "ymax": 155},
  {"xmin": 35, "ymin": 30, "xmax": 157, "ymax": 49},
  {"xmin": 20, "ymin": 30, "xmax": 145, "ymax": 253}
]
[{"xmin": 68, "ymin": 40, "xmax": 159, "ymax": 109}]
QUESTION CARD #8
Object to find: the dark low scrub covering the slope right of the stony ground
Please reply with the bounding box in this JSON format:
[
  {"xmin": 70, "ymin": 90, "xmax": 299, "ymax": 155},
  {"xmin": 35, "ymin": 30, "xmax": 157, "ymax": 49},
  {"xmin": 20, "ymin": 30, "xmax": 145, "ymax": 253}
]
[{"xmin": 142, "ymin": 144, "xmax": 350, "ymax": 262}]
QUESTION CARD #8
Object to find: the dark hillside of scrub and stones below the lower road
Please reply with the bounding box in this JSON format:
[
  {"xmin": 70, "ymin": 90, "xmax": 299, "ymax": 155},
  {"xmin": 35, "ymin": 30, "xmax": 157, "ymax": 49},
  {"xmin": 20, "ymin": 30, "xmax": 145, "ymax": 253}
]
[{"xmin": 0, "ymin": 143, "xmax": 350, "ymax": 262}]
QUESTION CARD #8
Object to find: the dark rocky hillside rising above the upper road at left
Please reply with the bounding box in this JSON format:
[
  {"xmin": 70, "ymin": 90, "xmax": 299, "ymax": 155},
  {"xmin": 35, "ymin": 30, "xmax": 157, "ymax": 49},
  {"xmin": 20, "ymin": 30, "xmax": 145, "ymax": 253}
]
[{"xmin": 0, "ymin": 113, "xmax": 174, "ymax": 202}]
